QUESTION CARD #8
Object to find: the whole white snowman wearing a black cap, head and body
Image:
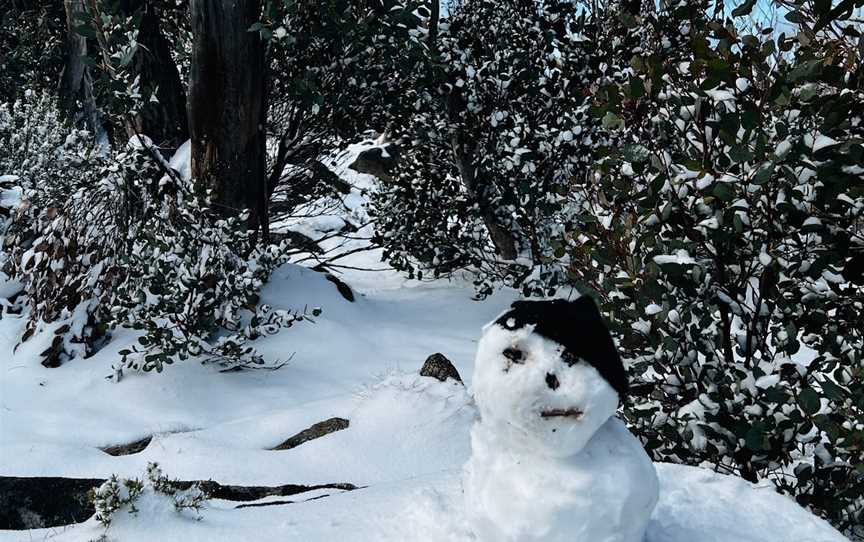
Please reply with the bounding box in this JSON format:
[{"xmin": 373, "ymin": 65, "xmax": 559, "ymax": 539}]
[{"xmin": 463, "ymin": 297, "xmax": 658, "ymax": 542}]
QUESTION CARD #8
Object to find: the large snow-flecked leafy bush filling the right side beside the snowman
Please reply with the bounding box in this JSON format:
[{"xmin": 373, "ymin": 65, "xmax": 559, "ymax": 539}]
[{"xmin": 561, "ymin": 3, "xmax": 864, "ymax": 529}]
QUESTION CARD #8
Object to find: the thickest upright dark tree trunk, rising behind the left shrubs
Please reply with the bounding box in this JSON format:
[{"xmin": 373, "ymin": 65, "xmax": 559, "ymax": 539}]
[{"xmin": 188, "ymin": 0, "xmax": 268, "ymax": 237}]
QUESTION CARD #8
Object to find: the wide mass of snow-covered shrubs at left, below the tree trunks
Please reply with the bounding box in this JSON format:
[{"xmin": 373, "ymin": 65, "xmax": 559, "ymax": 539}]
[{"xmin": 0, "ymin": 93, "xmax": 303, "ymax": 377}]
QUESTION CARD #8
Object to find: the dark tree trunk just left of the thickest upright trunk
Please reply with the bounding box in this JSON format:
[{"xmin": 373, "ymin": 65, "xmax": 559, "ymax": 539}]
[{"xmin": 121, "ymin": 0, "xmax": 189, "ymax": 152}]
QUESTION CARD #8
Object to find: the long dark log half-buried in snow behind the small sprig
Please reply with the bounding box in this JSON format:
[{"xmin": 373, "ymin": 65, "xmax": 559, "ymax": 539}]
[{"xmin": 0, "ymin": 476, "xmax": 359, "ymax": 530}]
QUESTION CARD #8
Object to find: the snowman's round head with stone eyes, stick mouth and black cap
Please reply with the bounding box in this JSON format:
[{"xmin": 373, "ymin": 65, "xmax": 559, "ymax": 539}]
[{"xmin": 472, "ymin": 297, "xmax": 627, "ymax": 457}]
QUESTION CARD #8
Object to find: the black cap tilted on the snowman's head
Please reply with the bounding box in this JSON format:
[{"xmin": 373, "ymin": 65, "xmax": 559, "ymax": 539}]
[{"xmin": 495, "ymin": 296, "xmax": 627, "ymax": 400}]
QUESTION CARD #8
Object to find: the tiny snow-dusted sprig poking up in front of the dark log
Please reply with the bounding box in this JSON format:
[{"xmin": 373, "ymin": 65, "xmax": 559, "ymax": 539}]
[{"xmin": 90, "ymin": 463, "xmax": 207, "ymax": 529}]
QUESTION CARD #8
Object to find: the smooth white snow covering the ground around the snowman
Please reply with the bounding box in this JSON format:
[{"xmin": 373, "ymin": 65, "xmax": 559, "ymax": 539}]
[{"xmin": 0, "ymin": 147, "xmax": 845, "ymax": 542}]
